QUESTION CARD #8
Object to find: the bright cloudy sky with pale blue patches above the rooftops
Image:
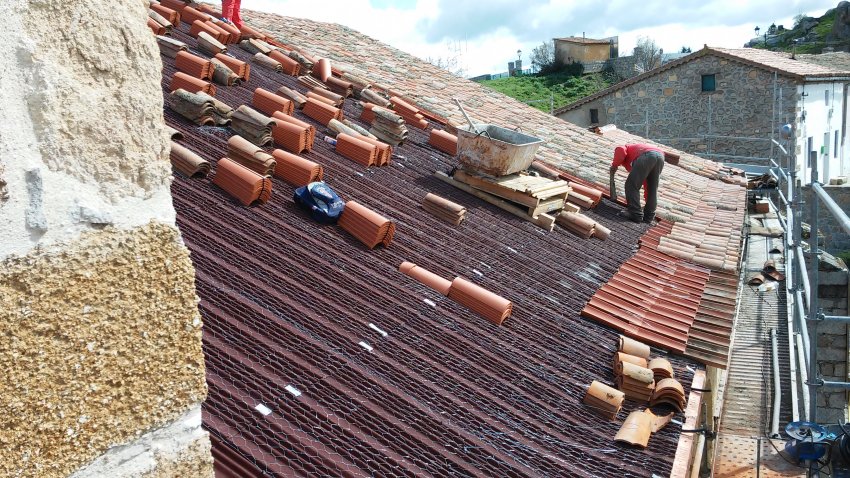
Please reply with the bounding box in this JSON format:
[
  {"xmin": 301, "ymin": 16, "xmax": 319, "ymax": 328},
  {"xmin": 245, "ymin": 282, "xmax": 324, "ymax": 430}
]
[{"xmin": 242, "ymin": 0, "xmax": 838, "ymax": 77}]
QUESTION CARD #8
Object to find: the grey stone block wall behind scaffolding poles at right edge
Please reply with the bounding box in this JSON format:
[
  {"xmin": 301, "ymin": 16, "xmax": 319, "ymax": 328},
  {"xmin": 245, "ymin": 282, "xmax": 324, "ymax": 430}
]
[{"xmin": 818, "ymin": 258, "xmax": 850, "ymax": 423}]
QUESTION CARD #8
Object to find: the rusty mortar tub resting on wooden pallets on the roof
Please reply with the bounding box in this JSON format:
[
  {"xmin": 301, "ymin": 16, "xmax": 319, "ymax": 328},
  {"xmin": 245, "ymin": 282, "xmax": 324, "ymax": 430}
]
[{"xmin": 457, "ymin": 123, "xmax": 543, "ymax": 177}]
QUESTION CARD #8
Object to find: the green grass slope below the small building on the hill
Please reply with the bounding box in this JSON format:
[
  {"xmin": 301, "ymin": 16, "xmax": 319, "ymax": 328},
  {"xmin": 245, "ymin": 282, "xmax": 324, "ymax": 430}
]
[{"xmin": 481, "ymin": 73, "xmax": 611, "ymax": 113}]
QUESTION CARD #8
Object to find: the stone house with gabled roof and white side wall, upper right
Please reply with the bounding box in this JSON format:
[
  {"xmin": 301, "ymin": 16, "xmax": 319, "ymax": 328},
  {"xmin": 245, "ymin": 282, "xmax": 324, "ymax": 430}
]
[{"xmin": 555, "ymin": 47, "xmax": 850, "ymax": 183}]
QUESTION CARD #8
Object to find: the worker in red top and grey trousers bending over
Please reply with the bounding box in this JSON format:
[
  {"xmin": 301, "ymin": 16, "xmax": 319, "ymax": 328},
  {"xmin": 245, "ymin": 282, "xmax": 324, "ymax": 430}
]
[{"xmin": 610, "ymin": 144, "xmax": 664, "ymax": 222}]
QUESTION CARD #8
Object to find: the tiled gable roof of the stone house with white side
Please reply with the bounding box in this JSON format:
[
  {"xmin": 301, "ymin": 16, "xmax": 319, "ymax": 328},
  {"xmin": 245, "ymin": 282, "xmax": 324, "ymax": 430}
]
[{"xmin": 553, "ymin": 46, "xmax": 850, "ymax": 116}]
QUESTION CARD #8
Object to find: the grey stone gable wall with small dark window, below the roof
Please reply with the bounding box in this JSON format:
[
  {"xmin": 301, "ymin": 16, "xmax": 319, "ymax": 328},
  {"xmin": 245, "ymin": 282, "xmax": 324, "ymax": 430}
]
[{"xmin": 560, "ymin": 55, "xmax": 797, "ymax": 164}]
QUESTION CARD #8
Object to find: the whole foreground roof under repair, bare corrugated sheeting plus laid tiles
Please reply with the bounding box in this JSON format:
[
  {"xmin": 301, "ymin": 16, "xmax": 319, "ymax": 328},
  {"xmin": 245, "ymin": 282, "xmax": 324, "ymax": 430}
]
[{"xmin": 156, "ymin": 5, "xmax": 745, "ymax": 476}]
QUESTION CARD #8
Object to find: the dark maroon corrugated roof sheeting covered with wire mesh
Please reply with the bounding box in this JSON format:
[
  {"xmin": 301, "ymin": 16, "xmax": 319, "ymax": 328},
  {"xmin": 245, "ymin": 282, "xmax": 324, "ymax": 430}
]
[{"xmin": 162, "ymin": 20, "xmax": 696, "ymax": 477}]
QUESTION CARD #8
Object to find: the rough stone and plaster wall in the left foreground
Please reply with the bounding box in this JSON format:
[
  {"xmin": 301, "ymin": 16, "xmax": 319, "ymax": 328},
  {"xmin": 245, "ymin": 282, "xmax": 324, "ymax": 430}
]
[{"xmin": 0, "ymin": 0, "xmax": 212, "ymax": 478}]
